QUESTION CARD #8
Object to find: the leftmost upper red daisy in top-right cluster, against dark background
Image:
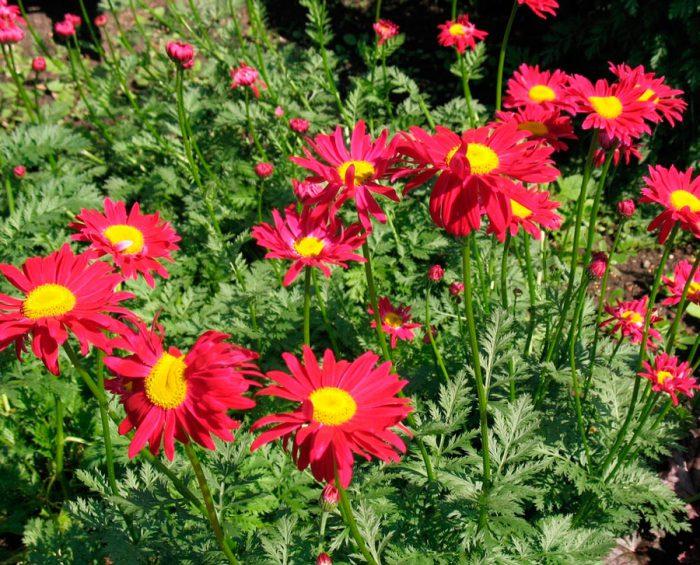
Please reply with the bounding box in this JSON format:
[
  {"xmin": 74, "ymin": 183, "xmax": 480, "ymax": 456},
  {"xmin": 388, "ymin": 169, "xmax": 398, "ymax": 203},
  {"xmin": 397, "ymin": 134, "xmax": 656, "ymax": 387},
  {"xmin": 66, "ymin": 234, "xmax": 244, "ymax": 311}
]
[{"xmin": 503, "ymin": 63, "xmax": 576, "ymax": 113}]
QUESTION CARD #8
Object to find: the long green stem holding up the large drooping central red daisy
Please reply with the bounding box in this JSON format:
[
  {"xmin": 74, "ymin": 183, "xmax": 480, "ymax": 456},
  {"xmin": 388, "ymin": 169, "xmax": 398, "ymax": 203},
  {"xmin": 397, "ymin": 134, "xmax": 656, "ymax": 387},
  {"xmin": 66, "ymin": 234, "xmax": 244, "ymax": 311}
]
[{"xmin": 462, "ymin": 232, "xmax": 491, "ymax": 530}]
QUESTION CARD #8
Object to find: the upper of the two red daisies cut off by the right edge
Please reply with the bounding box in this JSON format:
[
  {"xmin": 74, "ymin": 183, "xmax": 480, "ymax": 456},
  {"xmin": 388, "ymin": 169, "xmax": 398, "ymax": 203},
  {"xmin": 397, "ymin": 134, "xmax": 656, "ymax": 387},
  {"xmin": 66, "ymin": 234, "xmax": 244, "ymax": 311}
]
[{"xmin": 640, "ymin": 165, "xmax": 700, "ymax": 243}]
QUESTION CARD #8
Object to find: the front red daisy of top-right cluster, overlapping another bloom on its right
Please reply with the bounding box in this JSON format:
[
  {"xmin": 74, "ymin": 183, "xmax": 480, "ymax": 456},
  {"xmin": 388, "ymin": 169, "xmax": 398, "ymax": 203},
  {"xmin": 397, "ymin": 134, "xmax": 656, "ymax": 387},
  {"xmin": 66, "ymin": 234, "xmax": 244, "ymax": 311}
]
[{"xmin": 569, "ymin": 75, "xmax": 656, "ymax": 143}]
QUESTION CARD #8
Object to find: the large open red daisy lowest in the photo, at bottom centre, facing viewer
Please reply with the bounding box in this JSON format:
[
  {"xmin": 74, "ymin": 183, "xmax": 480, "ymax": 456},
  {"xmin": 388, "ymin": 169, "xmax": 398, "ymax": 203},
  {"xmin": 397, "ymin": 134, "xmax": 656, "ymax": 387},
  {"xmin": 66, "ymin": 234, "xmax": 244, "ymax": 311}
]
[{"xmin": 250, "ymin": 346, "xmax": 411, "ymax": 488}]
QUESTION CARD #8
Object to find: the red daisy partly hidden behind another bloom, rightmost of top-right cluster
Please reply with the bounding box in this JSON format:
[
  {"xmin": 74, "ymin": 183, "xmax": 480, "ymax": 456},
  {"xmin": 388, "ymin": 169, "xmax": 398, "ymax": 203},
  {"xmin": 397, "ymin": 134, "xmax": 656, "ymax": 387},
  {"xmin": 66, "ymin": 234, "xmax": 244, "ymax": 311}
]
[{"xmin": 610, "ymin": 63, "xmax": 688, "ymax": 126}]
